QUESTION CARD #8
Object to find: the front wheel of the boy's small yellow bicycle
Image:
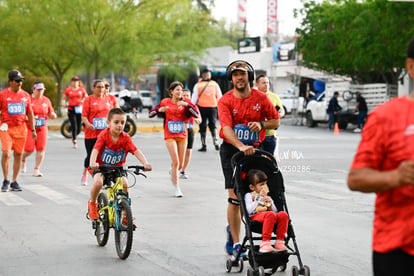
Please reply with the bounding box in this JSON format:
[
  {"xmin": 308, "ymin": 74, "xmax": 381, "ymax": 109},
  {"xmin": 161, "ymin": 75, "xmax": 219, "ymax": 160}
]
[{"xmin": 115, "ymin": 200, "xmax": 134, "ymax": 259}]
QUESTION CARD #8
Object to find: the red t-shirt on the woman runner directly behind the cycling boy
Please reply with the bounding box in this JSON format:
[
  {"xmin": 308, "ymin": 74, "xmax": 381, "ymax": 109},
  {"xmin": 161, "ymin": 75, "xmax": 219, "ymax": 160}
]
[{"xmin": 82, "ymin": 95, "xmax": 112, "ymax": 139}]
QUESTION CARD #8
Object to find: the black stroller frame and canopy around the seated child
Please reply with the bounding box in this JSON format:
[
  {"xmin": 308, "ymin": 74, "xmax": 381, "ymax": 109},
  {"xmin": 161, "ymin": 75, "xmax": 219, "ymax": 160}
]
[{"xmin": 226, "ymin": 150, "xmax": 310, "ymax": 276}]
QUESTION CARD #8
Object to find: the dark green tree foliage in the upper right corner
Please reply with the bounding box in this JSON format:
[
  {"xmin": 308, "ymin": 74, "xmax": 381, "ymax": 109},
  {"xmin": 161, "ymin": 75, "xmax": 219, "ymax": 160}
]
[{"xmin": 296, "ymin": 0, "xmax": 414, "ymax": 84}]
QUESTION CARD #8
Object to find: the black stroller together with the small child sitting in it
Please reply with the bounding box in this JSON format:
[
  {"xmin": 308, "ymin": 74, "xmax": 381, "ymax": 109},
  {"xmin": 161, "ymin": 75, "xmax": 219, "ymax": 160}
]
[{"xmin": 226, "ymin": 150, "xmax": 310, "ymax": 276}]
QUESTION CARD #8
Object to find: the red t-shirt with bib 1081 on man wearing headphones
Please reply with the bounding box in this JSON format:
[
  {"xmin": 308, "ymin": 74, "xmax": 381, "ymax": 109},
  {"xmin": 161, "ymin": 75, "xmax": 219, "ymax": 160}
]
[{"xmin": 217, "ymin": 88, "xmax": 279, "ymax": 144}]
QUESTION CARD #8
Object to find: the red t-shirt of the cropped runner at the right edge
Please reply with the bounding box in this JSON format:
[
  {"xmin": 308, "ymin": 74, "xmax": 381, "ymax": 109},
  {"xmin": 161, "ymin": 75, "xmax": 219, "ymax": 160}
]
[{"xmin": 351, "ymin": 96, "xmax": 414, "ymax": 255}]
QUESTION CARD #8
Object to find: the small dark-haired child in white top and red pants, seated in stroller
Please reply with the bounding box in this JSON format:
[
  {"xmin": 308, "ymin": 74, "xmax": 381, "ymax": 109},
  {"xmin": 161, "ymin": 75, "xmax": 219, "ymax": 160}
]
[{"xmin": 244, "ymin": 169, "xmax": 289, "ymax": 253}]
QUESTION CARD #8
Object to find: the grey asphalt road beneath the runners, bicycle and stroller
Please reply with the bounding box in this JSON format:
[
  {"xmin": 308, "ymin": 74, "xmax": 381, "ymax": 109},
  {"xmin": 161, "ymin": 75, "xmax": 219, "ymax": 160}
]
[{"xmin": 0, "ymin": 121, "xmax": 374, "ymax": 276}]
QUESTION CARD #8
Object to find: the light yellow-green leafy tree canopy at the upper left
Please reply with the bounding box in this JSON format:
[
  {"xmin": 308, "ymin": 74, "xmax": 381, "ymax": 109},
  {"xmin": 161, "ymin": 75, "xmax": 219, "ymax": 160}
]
[{"xmin": 0, "ymin": 0, "xmax": 223, "ymax": 115}]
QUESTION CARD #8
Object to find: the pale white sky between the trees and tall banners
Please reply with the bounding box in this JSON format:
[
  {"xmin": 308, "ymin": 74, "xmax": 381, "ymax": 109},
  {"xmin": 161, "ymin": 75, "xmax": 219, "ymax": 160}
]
[{"xmin": 212, "ymin": 0, "xmax": 303, "ymax": 37}]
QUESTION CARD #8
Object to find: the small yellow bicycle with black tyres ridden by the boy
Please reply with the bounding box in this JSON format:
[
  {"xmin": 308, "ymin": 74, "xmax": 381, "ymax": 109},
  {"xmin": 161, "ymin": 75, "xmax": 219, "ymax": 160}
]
[{"xmin": 86, "ymin": 165, "xmax": 146, "ymax": 260}]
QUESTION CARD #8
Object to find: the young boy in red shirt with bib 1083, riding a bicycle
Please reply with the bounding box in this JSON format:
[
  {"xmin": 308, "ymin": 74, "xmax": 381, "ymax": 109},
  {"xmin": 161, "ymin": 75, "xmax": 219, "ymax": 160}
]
[{"xmin": 88, "ymin": 108, "xmax": 152, "ymax": 220}]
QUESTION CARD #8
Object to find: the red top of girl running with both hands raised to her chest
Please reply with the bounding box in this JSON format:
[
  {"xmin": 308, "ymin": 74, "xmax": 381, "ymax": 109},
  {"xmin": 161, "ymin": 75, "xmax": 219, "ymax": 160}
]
[{"xmin": 159, "ymin": 98, "xmax": 191, "ymax": 139}]
